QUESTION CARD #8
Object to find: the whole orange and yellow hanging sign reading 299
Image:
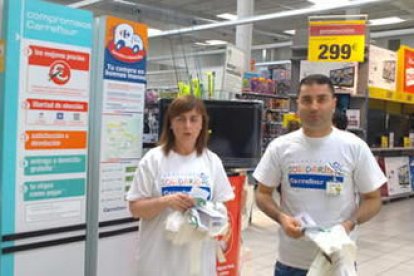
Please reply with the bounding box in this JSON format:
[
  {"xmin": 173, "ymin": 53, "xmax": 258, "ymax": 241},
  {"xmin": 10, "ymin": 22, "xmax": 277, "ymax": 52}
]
[{"xmin": 308, "ymin": 20, "xmax": 365, "ymax": 62}]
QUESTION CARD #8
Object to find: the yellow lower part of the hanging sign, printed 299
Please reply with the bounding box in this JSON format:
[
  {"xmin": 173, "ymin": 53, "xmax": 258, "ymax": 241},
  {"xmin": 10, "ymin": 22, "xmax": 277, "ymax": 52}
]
[{"xmin": 308, "ymin": 35, "xmax": 365, "ymax": 62}]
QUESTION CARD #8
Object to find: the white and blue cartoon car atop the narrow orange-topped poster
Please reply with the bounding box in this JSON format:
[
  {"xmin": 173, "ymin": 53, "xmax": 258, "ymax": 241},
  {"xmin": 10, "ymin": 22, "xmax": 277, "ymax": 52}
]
[{"xmin": 107, "ymin": 23, "xmax": 145, "ymax": 63}]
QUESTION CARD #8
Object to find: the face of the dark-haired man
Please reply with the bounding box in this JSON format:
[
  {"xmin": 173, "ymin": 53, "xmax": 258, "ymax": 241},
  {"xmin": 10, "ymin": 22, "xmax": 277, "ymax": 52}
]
[{"xmin": 297, "ymin": 84, "xmax": 336, "ymax": 131}]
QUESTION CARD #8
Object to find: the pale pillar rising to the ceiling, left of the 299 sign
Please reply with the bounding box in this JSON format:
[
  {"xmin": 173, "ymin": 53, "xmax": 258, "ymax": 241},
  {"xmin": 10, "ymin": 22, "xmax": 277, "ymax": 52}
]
[{"xmin": 236, "ymin": 0, "xmax": 254, "ymax": 72}]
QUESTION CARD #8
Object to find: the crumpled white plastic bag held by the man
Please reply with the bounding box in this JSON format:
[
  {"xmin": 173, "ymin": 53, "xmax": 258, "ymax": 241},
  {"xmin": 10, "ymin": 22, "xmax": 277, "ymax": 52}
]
[{"xmin": 305, "ymin": 225, "xmax": 357, "ymax": 276}]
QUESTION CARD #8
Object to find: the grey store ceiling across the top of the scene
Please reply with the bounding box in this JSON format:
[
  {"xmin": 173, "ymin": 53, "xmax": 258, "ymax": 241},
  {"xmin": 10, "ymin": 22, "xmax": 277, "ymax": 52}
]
[{"xmin": 49, "ymin": 0, "xmax": 414, "ymax": 45}]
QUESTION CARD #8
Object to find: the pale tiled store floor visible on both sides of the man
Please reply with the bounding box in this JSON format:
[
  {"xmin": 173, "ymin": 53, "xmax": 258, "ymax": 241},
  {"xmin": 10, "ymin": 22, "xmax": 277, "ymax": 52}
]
[{"xmin": 242, "ymin": 198, "xmax": 414, "ymax": 276}]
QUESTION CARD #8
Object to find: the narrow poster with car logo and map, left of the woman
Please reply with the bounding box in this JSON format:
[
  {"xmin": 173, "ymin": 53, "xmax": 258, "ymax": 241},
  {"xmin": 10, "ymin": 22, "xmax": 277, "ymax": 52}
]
[{"xmin": 98, "ymin": 16, "xmax": 148, "ymax": 221}]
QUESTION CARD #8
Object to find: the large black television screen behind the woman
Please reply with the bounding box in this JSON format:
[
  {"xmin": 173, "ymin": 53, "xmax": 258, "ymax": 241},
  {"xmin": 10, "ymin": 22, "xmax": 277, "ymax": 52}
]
[{"xmin": 158, "ymin": 99, "xmax": 263, "ymax": 168}]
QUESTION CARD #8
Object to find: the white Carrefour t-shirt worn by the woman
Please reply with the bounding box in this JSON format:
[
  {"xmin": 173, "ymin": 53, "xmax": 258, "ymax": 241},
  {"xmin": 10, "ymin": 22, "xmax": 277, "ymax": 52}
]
[{"xmin": 127, "ymin": 147, "xmax": 234, "ymax": 276}]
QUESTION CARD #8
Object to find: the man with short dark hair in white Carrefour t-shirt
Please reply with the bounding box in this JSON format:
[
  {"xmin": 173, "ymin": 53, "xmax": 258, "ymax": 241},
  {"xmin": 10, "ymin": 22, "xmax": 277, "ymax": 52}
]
[{"xmin": 253, "ymin": 75, "xmax": 386, "ymax": 276}]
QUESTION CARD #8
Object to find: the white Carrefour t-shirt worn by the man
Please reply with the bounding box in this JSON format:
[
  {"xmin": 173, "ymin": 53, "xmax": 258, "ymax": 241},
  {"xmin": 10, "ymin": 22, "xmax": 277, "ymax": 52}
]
[{"xmin": 253, "ymin": 128, "xmax": 387, "ymax": 269}]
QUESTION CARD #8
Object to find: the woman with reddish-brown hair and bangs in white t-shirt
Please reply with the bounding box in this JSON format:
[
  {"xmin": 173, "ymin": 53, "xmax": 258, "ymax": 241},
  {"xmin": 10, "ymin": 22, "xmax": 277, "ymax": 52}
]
[{"xmin": 127, "ymin": 96, "xmax": 234, "ymax": 276}]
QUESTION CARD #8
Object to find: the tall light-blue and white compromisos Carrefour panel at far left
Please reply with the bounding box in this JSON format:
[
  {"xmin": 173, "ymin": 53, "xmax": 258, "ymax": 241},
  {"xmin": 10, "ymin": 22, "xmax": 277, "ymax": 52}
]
[{"xmin": 0, "ymin": 0, "xmax": 93, "ymax": 276}]
